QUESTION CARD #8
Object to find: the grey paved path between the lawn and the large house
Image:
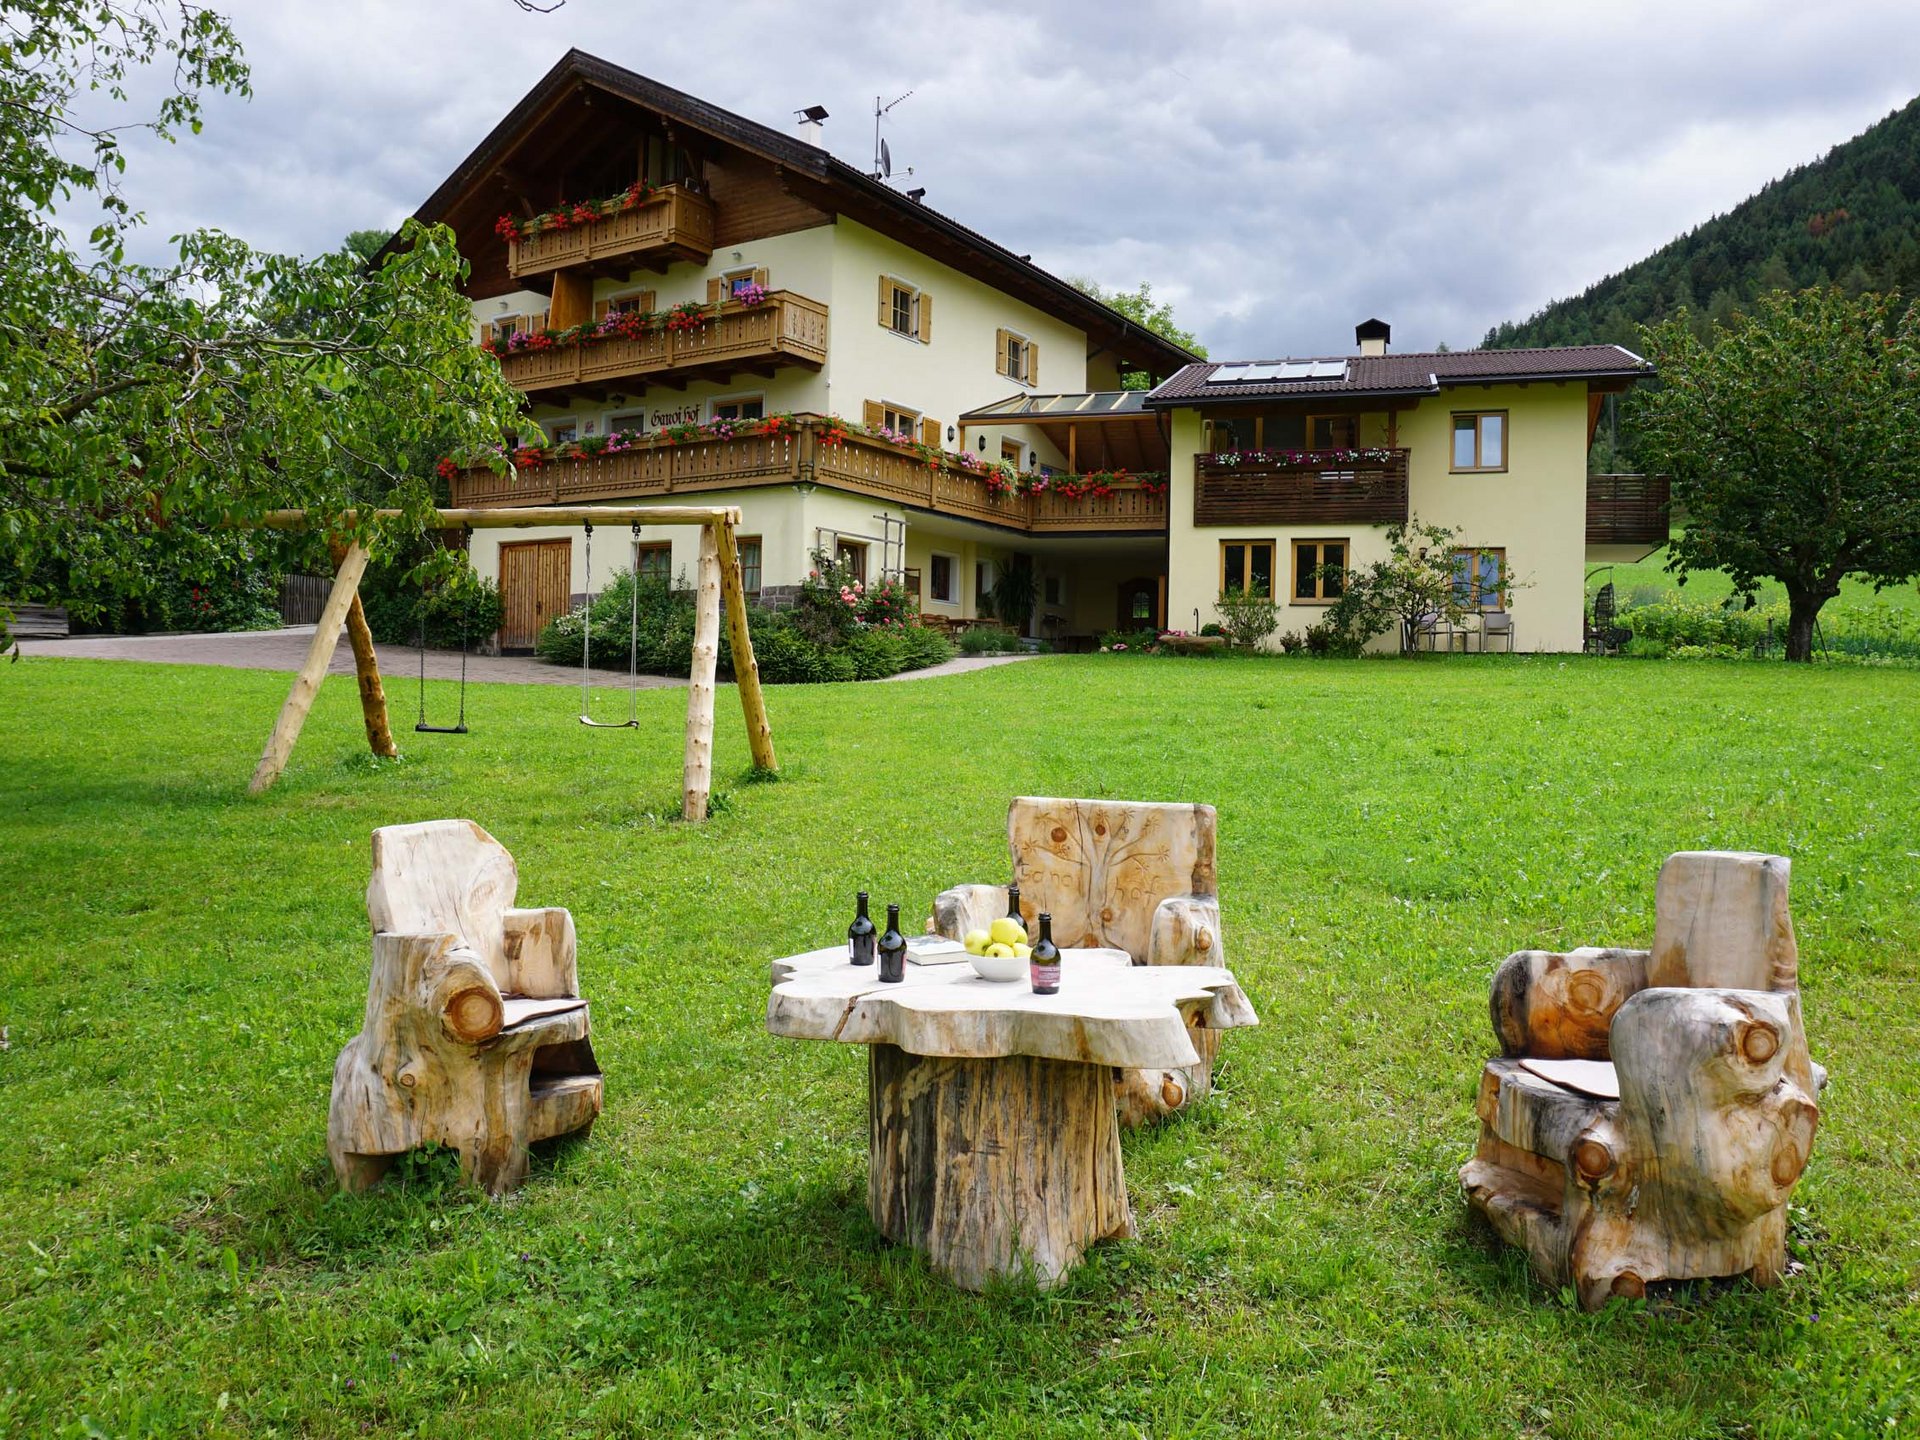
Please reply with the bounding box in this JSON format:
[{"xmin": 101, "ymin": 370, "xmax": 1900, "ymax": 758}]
[{"xmin": 19, "ymin": 626, "xmax": 1029, "ymax": 689}]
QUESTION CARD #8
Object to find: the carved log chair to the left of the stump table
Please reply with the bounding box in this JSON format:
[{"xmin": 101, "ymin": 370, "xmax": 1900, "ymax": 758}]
[{"xmin": 326, "ymin": 820, "xmax": 601, "ymax": 1196}]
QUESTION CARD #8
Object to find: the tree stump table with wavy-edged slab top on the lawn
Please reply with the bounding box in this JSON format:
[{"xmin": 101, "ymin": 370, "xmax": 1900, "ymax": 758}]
[{"xmin": 766, "ymin": 947, "xmax": 1260, "ymax": 1290}]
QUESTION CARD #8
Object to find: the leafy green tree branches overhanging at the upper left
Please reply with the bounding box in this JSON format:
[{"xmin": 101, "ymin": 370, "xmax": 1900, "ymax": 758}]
[{"xmin": 0, "ymin": 0, "xmax": 520, "ymax": 641}]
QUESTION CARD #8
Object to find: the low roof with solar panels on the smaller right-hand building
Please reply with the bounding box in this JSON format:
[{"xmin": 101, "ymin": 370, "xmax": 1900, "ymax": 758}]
[{"xmin": 1146, "ymin": 346, "xmax": 1653, "ymax": 409}]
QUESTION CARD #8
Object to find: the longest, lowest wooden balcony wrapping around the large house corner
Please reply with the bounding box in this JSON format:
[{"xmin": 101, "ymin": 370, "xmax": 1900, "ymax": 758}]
[{"xmin": 453, "ymin": 415, "xmax": 1167, "ymax": 536}]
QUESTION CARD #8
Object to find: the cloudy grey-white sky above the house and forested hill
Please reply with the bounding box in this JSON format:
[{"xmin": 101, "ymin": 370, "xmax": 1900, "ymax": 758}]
[{"xmin": 101, "ymin": 0, "xmax": 1920, "ymax": 357}]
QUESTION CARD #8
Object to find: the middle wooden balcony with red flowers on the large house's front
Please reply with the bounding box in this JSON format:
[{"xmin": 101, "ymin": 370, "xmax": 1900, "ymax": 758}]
[{"xmin": 499, "ymin": 290, "xmax": 828, "ymax": 394}]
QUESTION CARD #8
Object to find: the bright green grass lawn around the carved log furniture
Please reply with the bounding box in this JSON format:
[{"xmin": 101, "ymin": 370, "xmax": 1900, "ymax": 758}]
[{"xmin": 0, "ymin": 657, "xmax": 1920, "ymax": 1440}]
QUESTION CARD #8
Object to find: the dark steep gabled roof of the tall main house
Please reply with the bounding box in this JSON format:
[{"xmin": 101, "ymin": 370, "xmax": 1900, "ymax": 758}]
[{"xmin": 415, "ymin": 50, "xmax": 1194, "ymax": 372}]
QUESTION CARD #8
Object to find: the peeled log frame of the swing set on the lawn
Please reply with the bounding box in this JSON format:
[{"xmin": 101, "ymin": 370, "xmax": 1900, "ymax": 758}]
[{"xmin": 248, "ymin": 505, "xmax": 780, "ymax": 824}]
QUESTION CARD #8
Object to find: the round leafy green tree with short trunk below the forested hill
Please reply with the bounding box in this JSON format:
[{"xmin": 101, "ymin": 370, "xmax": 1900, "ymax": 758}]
[{"xmin": 1642, "ymin": 286, "xmax": 1920, "ymax": 660}]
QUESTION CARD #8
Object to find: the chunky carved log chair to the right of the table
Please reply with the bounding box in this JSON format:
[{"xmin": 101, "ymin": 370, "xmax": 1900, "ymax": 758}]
[{"xmin": 1459, "ymin": 851, "xmax": 1826, "ymax": 1309}]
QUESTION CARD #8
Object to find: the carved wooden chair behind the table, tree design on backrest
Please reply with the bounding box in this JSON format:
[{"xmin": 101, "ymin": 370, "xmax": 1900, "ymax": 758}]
[{"xmin": 927, "ymin": 795, "xmax": 1227, "ymax": 1125}]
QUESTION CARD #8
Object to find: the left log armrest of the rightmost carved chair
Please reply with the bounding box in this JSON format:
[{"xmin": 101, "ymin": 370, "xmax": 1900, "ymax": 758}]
[{"xmin": 1490, "ymin": 947, "xmax": 1647, "ymax": 1060}]
